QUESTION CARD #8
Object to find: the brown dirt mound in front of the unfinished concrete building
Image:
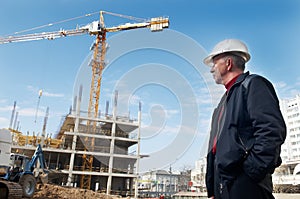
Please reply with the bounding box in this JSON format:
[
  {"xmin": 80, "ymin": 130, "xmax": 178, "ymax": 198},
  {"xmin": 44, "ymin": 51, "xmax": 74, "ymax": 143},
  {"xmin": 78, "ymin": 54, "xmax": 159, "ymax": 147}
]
[{"xmin": 33, "ymin": 184, "xmax": 120, "ymax": 199}]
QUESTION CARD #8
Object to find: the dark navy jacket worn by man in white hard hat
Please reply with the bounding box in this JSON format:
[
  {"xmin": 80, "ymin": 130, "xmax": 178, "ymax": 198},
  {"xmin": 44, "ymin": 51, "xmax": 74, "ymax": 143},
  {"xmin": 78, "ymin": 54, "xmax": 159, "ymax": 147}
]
[{"xmin": 206, "ymin": 72, "xmax": 286, "ymax": 197}]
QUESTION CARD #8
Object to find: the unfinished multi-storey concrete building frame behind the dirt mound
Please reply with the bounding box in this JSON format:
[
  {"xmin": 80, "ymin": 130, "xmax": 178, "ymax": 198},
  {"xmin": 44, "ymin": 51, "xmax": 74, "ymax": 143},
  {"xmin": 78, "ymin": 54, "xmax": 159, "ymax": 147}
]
[{"xmin": 8, "ymin": 92, "xmax": 141, "ymax": 195}]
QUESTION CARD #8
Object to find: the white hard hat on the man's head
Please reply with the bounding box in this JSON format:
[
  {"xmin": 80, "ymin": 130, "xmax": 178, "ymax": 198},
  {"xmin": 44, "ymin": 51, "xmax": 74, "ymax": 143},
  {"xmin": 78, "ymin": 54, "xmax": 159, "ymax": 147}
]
[{"xmin": 203, "ymin": 39, "xmax": 250, "ymax": 66}]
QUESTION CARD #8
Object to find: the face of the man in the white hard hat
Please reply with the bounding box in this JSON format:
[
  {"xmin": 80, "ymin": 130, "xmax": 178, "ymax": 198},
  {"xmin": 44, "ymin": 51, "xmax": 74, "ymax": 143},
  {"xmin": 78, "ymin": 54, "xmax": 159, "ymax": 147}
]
[{"xmin": 210, "ymin": 54, "xmax": 228, "ymax": 84}]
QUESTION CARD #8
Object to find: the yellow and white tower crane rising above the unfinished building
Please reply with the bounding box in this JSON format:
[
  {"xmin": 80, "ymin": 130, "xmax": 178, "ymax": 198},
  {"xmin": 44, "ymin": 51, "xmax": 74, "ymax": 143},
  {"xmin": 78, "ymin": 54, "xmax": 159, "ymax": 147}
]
[{"xmin": 0, "ymin": 11, "xmax": 169, "ymax": 189}]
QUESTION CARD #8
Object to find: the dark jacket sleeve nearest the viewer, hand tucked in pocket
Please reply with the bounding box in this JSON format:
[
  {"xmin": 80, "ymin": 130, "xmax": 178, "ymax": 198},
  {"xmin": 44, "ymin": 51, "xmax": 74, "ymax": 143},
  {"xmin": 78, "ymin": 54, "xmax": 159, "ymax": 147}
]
[{"xmin": 243, "ymin": 76, "xmax": 286, "ymax": 182}]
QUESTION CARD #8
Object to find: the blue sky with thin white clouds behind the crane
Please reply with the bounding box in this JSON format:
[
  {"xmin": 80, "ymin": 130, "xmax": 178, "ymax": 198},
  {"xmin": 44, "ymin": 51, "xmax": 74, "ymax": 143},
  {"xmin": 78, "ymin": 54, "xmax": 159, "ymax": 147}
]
[{"xmin": 0, "ymin": 0, "xmax": 300, "ymax": 172}]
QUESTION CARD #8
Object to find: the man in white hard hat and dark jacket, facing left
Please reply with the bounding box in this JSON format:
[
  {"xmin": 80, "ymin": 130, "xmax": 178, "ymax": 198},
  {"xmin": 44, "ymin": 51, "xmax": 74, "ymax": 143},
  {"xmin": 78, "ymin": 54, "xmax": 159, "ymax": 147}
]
[{"xmin": 204, "ymin": 39, "xmax": 286, "ymax": 199}]
